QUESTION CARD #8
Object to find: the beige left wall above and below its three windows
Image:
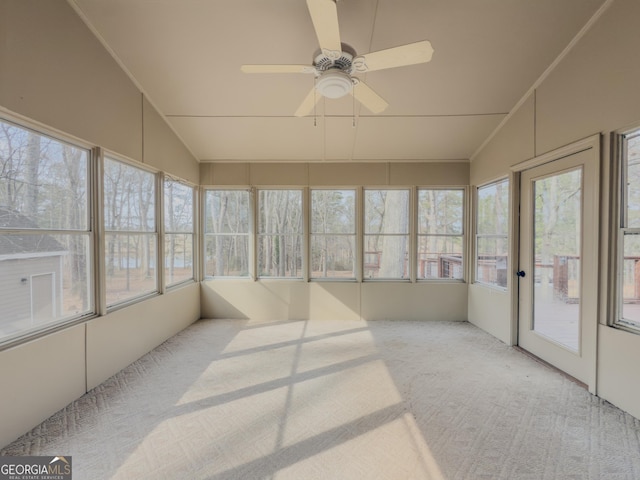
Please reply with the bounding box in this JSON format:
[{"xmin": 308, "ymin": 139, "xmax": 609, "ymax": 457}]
[{"xmin": 0, "ymin": 0, "xmax": 200, "ymax": 446}]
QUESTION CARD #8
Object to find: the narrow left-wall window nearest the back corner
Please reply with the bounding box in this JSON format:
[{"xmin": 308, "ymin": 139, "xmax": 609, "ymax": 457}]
[{"xmin": 164, "ymin": 177, "xmax": 194, "ymax": 286}]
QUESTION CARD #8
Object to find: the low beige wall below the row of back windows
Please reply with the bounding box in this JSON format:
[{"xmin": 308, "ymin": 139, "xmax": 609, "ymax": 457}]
[{"xmin": 201, "ymin": 279, "xmax": 467, "ymax": 321}]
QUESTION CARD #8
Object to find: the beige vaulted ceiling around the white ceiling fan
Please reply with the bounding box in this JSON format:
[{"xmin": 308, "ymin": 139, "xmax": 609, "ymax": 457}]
[{"xmin": 69, "ymin": 0, "xmax": 604, "ymax": 161}]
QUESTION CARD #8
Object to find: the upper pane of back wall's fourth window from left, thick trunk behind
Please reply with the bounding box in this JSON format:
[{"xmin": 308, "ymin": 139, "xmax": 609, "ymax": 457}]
[{"xmin": 364, "ymin": 190, "xmax": 409, "ymax": 234}]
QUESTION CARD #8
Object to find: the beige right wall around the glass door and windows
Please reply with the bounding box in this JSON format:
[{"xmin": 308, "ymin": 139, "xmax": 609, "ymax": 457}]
[{"xmin": 468, "ymin": 0, "xmax": 640, "ymax": 417}]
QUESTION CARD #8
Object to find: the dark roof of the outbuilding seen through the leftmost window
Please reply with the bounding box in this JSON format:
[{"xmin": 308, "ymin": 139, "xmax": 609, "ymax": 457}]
[{"xmin": 0, "ymin": 207, "xmax": 66, "ymax": 258}]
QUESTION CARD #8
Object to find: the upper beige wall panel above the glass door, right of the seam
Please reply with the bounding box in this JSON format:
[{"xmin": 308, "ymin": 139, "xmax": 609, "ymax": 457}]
[{"xmin": 536, "ymin": 0, "xmax": 640, "ymax": 155}]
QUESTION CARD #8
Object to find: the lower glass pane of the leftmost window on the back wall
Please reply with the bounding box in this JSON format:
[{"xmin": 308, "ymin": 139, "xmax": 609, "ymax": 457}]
[{"xmin": 204, "ymin": 235, "xmax": 249, "ymax": 277}]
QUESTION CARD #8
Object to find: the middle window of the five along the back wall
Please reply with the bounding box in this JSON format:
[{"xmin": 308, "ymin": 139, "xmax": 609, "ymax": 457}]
[{"xmin": 311, "ymin": 190, "xmax": 356, "ymax": 279}]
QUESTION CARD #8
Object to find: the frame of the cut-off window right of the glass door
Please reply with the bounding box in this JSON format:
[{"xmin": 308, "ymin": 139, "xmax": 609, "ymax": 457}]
[{"xmin": 609, "ymin": 126, "xmax": 640, "ymax": 334}]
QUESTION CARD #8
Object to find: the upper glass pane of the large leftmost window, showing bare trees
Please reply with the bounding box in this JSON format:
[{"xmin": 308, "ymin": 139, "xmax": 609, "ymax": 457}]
[{"xmin": 0, "ymin": 122, "xmax": 89, "ymax": 230}]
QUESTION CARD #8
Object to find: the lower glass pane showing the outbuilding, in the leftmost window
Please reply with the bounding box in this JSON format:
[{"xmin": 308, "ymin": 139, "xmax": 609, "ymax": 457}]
[{"xmin": 0, "ymin": 234, "xmax": 94, "ymax": 338}]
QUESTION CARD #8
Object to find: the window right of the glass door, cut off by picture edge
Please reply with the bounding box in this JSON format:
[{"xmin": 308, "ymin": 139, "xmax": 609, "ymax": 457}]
[{"xmin": 617, "ymin": 129, "xmax": 640, "ymax": 329}]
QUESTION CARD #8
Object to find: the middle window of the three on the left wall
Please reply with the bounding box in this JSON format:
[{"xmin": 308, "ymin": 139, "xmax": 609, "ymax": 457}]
[{"xmin": 104, "ymin": 158, "xmax": 158, "ymax": 306}]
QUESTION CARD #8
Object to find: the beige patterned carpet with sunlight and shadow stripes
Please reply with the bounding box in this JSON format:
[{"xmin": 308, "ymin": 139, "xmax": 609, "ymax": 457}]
[{"xmin": 0, "ymin": 320, "xmax": 640, "ymax": 480}]
